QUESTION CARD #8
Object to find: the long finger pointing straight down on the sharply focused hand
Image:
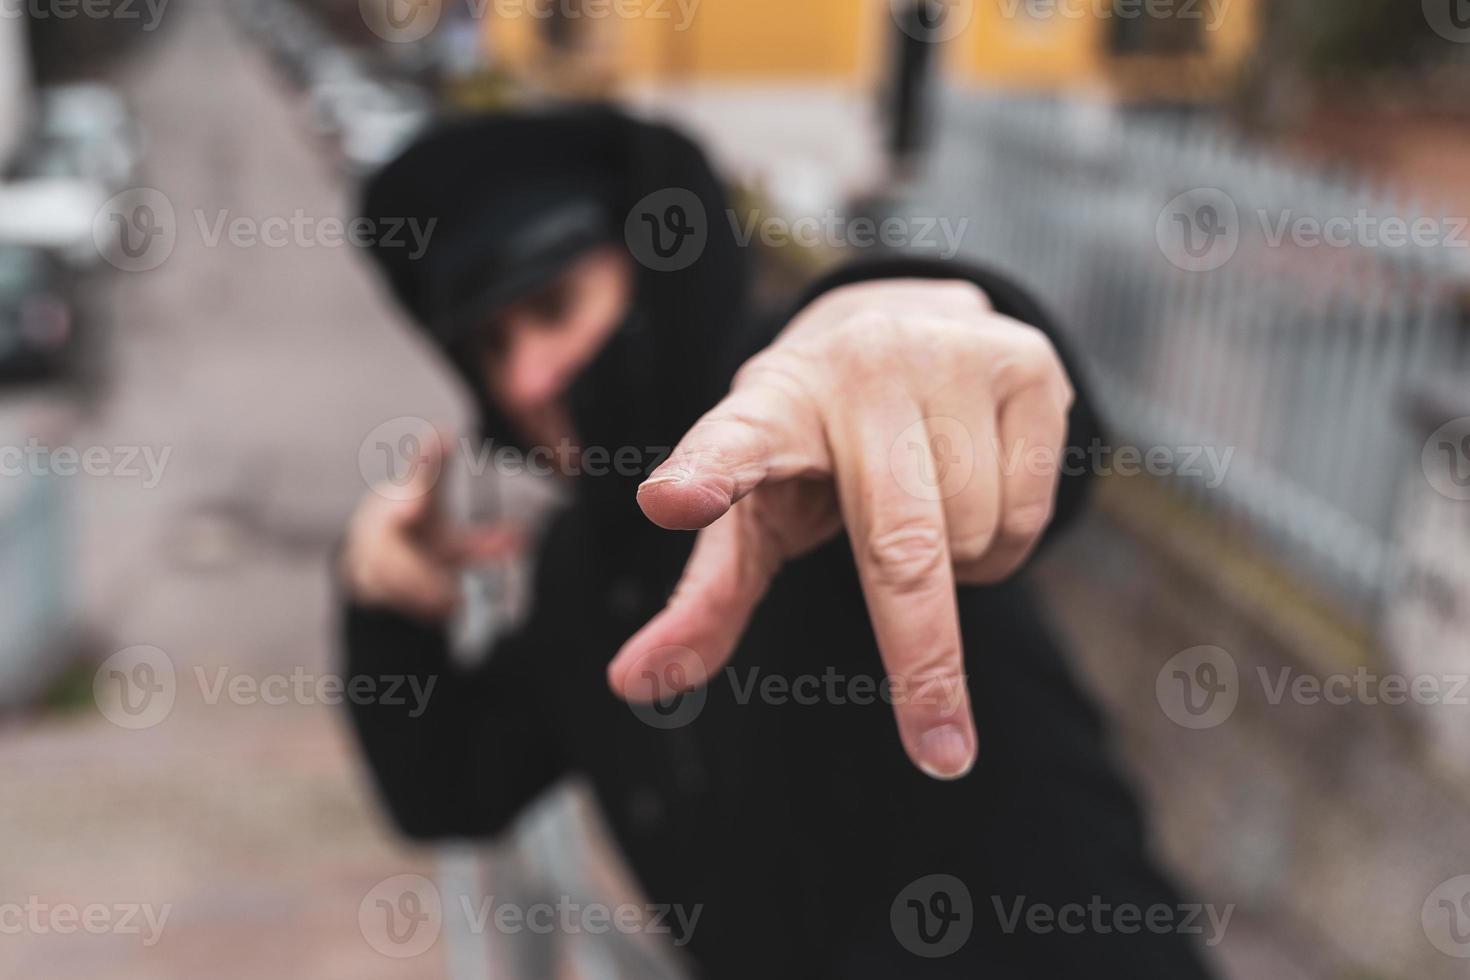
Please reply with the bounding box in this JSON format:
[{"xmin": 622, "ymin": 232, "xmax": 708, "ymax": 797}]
[{"xmin": 829, "ymin": 395, "xmax": 976, "ymax": 779}]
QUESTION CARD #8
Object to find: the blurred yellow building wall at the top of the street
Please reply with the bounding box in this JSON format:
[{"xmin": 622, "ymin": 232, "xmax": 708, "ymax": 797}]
[{"xmin": 487, "ymin": 0, "xmax": 1260, "ymax": 94}]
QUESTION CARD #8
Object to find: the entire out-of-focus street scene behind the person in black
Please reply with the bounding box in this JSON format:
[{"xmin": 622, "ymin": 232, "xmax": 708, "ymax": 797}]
[{"xmin": 0, "ymin": 0, "xmax": 1470, "ymax": 980}]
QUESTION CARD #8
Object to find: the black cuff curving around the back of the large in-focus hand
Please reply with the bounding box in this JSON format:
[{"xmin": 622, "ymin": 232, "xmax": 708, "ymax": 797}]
[{"xmin": 782, "ymin": 257, "xmax": 1103, "ymax": 542}]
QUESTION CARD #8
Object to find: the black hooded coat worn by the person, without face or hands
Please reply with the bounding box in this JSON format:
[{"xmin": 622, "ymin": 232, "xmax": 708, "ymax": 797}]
[{"xmin": 343, "ymin": 107, "xmax": 1207, "ymax": 980}]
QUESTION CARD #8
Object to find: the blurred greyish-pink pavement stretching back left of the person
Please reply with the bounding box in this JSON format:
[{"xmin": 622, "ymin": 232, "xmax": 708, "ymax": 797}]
[{"xmin": 0, "ymin": 1, "xmax": 456, "ymax": 980}]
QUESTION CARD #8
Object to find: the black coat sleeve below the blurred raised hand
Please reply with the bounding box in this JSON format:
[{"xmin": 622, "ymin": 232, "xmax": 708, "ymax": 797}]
[{"xmin": 341, "ymin": 602, "xmax": 566, "ymax": 840}]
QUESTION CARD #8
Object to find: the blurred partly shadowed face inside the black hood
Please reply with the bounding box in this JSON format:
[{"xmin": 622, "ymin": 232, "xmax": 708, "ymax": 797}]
[{"xmin": 482, "ymin": 245, "xmax": 634, "ymax": 444}]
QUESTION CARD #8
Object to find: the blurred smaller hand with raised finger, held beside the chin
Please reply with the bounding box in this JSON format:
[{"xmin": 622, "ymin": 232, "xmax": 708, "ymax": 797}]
[{"xmin": 338, "ymin": 433, "xmax": 522, "ymax": 621}]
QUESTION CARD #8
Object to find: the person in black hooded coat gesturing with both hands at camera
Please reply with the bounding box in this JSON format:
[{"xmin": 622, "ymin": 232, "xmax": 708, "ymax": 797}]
[{"xmin": 338, "ymin": 107, "xmax": 1208, "ymax": 980}]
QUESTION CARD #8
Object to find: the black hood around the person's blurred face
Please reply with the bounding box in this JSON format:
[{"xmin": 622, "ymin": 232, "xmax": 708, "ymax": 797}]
[{"xmin": 360, "ymin": 104, "xmax": 748, "ymax": 552}]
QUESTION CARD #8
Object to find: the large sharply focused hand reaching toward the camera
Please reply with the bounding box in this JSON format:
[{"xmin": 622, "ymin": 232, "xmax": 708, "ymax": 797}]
[{"xmin": 609, "ymin": 279, "xmax": 1073, "ymax": 779}]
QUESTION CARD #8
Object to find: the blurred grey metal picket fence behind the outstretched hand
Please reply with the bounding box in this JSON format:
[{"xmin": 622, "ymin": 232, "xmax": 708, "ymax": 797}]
[{"xmin": 906, "ymin": 96, "xmax": 1470, "ymax": 620}]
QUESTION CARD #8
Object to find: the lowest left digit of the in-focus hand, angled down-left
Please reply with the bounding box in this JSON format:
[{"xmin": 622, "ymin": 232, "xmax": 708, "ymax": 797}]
[{"xmin": 607, "ymin": 505, "xmax": 781, "ymax": 702}]
